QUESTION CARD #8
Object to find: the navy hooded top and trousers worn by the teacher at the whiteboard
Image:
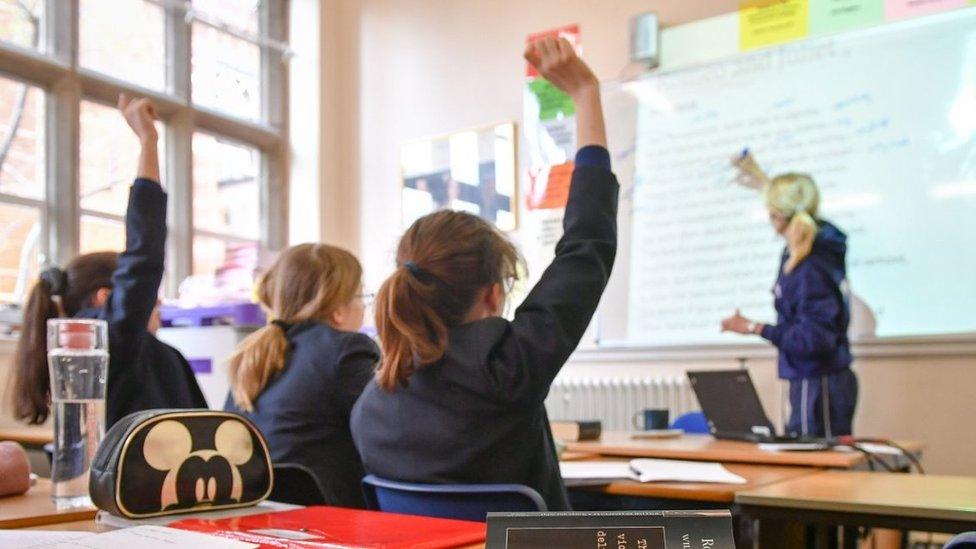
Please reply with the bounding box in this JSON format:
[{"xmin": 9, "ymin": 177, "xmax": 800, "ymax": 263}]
[{"xmin": 762, "ymin": 221, "xmax": 857, "ymax": 437}]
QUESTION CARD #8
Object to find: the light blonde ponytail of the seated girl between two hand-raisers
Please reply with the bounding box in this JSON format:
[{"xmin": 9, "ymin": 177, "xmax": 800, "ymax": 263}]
[{"xmin": 228, "ymin": 324, "xmax": 289, "ymax": 412}]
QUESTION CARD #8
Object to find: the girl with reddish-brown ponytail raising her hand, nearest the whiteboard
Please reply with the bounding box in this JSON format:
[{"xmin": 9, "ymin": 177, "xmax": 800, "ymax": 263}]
[{"xmin": 352, "ymin": 38, "xmax": 618, "ymax": 510}]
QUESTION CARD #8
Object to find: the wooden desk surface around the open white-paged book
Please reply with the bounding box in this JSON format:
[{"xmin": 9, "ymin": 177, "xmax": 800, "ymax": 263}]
[{"xmin": 571, "ymin": 463, "xmax": 821, "ymax": 503}]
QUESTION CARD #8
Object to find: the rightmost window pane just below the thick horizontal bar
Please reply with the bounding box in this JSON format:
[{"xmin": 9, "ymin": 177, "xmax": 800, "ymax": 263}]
[{"xmin": 193, "ymin": 133, "xmax": 261, "ymax": 240}]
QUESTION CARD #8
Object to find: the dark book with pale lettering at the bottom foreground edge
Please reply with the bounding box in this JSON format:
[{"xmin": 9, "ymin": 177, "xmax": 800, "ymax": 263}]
[{"xmin": 486, "ymin": 510, "xmax": 735, "ymax": 549}]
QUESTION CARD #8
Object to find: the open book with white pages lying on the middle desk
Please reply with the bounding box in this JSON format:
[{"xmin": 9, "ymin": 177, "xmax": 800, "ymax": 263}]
[{"xmin": 559, "ymin": 459, "xmax": 746, "ymax": 486}]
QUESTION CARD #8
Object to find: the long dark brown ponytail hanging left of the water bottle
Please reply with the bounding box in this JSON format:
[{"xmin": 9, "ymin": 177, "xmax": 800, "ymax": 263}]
[{"xmin": 12, "ymin": 271, "xmax": 61, "ymax": 425}]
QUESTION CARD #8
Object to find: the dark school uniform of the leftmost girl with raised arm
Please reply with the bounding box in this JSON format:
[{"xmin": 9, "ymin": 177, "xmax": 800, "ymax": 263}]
[{"xmin": 76, "ymin": 178, "xmax": 207, "ymax": 428}]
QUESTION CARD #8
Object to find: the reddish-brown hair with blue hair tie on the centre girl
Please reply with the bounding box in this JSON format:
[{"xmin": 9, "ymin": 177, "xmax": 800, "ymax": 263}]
[{"xmin": 376, "ymin": 210, "xmax": 522, "ymax": 391}]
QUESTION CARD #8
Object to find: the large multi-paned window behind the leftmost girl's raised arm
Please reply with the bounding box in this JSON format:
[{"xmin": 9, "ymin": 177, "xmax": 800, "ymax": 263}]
[{"xmin": 0, "ymin": 0, "xmax": 288, "ymax": 305}]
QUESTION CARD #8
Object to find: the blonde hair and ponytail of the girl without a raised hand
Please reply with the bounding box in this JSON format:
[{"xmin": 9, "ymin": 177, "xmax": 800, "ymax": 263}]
[{"xmin": 228, "ymin": 244, "xmax": 363, "ymax": 412}]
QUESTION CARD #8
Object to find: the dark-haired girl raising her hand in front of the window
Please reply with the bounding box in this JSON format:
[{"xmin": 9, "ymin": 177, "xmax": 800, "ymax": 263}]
[{"xmin": 14, "ymin": 94, "xmax": 207, "ymax": 428}]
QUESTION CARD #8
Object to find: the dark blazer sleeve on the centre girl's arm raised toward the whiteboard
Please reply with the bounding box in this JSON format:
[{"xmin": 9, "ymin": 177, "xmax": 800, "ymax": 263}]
[{"xmin": 490, "ymin": 152, "xmax": 619, "ymax": 404}]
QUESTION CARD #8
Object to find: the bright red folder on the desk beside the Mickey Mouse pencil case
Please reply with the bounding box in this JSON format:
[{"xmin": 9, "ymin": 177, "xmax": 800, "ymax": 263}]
[{"xmin": 170, "ymin": 507, "xmax": 485, "ymax": 549}]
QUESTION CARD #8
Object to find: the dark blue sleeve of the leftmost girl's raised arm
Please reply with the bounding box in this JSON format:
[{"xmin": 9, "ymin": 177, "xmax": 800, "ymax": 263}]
[{"xmin": 103, "ymin": 178, "xmax": 166, "ymax": 350}]
